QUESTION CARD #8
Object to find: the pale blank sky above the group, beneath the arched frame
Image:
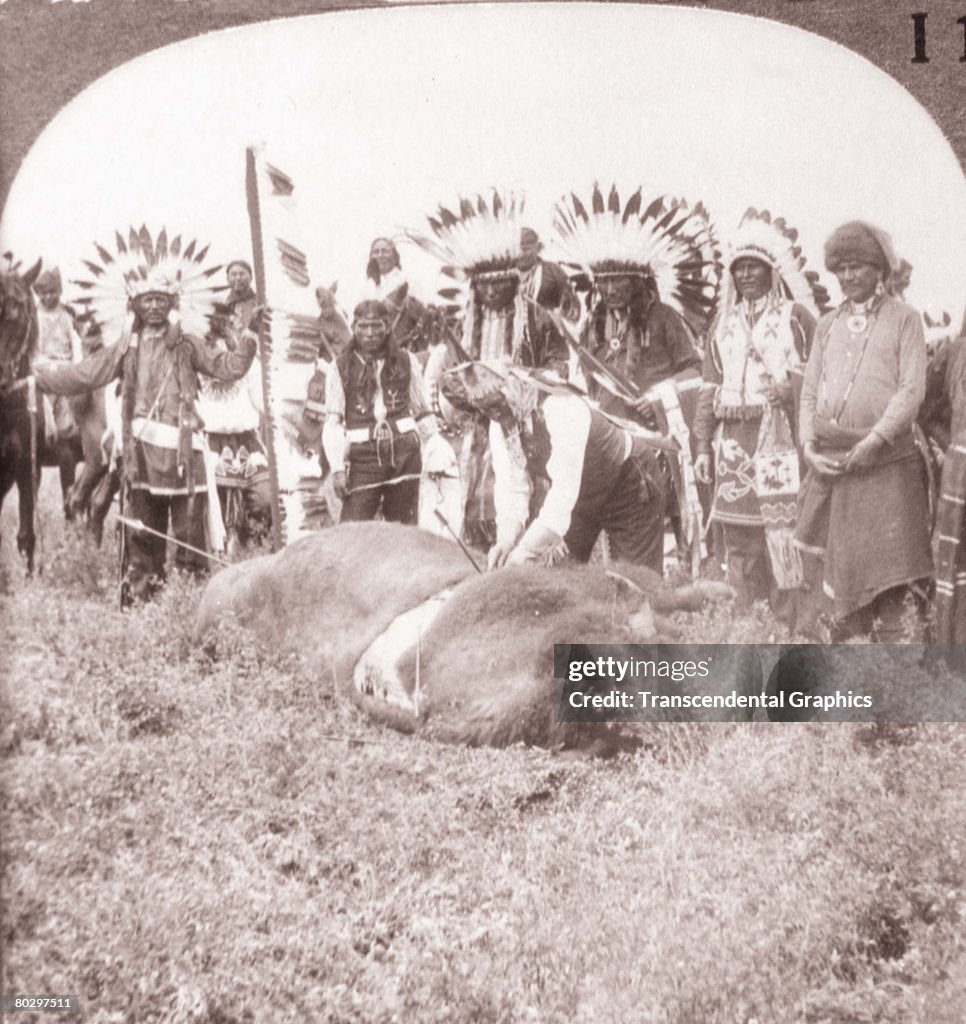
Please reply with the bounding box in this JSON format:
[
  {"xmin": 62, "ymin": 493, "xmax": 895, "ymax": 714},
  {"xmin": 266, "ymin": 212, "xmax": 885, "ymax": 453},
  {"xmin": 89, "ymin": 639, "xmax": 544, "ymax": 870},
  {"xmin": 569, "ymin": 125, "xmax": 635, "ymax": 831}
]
[{"xmin": 0, "ymin": 3, "xmax": 966, "ymax": 324}]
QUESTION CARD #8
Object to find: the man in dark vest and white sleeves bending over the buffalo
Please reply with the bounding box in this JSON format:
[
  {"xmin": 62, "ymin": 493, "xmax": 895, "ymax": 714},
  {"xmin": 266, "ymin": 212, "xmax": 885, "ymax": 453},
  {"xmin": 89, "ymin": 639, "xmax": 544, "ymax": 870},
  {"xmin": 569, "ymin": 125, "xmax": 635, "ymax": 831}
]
[{"xmin": 440, "ymin": 362, "xmax": 664, "ymax": 573}]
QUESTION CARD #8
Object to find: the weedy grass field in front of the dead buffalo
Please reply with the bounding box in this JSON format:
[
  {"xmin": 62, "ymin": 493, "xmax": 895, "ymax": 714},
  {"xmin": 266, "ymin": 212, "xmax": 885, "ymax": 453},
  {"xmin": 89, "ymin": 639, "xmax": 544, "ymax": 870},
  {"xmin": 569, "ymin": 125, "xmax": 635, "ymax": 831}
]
[{"xmin": 0, "ymin": 477, "xmax": 966, "ymax": 1024}]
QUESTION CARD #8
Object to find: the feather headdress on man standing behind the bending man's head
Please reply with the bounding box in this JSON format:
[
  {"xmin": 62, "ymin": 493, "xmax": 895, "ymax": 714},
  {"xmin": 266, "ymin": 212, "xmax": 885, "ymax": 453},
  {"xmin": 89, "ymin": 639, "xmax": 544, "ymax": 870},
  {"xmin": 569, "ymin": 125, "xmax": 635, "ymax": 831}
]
[{"xmin": 406, "ymin": 189, "xmax": 523, "ymax": 281}]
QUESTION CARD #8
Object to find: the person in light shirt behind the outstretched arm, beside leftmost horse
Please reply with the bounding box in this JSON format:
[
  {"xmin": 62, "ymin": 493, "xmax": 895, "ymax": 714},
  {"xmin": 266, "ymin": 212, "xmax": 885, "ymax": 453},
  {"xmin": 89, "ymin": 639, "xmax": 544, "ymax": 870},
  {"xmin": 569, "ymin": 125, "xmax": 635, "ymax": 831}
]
[{"xmin": 34, "ymin": 267, "xmax": 84, "ymax": 519}]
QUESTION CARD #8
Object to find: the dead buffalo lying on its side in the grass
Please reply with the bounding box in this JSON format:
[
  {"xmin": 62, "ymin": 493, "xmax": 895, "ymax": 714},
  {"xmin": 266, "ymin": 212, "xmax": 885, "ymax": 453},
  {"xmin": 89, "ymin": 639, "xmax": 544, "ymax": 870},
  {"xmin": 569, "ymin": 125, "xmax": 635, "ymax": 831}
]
[{"xmin": 196, "ymin": 523, "xmax": 741, "ymax": 746}]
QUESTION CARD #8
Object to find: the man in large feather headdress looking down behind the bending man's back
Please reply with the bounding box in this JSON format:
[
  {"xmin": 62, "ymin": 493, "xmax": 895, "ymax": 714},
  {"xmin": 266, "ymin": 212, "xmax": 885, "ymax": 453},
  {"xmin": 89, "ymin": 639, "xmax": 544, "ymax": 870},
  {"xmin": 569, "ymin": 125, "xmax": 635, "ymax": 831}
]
[{"xmin": 554, "ymin": 184, "xmax": 719, "ymax": 569}]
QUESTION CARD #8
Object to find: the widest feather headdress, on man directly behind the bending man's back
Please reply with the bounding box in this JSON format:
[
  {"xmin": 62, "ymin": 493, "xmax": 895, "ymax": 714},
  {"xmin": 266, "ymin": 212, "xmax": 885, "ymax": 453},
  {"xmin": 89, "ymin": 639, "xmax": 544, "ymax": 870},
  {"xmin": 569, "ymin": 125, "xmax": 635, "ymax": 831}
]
[{"xmin": 554, "ymin": 183, "xmax": 721, "ymax": 330}]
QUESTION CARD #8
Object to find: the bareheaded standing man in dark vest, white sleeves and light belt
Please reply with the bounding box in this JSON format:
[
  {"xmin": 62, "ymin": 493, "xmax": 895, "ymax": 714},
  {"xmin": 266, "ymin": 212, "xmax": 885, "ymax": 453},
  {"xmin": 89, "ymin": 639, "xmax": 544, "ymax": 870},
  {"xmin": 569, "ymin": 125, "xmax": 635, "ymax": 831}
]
[{"xmin": 322, "ymin": 300, "xmax": 453, "ymax": 523}]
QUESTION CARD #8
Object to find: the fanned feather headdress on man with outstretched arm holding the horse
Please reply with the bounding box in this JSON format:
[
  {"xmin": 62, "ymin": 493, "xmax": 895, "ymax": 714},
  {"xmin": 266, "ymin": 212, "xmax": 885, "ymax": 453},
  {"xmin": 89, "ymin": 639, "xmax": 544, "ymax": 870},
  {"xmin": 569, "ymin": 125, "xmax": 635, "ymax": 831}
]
[{"xmin": 71, "ymin": 225, "xmax": 224, "ymax": 343}]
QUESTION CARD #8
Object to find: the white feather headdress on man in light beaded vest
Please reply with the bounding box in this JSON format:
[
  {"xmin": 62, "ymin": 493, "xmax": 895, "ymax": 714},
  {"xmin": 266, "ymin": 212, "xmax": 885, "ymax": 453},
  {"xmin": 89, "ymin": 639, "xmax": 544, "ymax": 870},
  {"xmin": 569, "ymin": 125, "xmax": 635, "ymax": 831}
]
[{"xmin": 727, "ymin": 207, "xmax": 829, "ymax": 316}]
